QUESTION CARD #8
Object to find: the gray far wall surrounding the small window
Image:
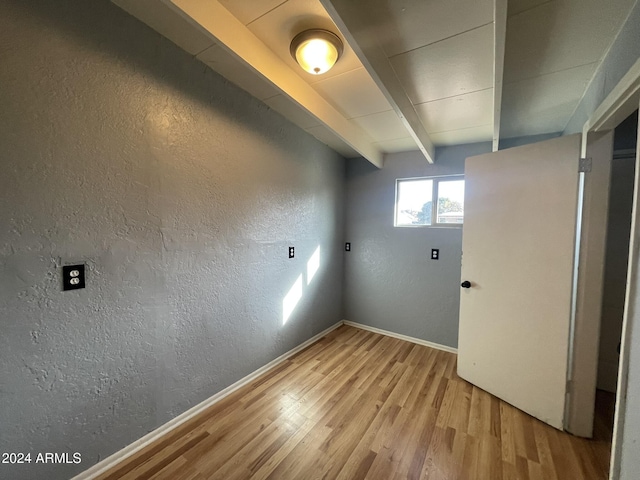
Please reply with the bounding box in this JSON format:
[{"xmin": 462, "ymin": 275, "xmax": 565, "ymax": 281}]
[{"xmin": 345, "ymin": 143, "xmax": 491, "ymax": 347}]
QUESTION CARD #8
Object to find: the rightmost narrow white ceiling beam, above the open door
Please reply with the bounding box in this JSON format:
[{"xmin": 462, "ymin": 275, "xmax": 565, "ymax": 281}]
[{"xmin": 493, "ymin": 0, "xmax": 507, "ymax": 152}]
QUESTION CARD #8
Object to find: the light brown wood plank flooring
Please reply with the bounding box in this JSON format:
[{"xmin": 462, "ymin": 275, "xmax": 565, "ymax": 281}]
[{"xmin": 99, "ymin": 326, "xmax": 613, "ymax": 480}]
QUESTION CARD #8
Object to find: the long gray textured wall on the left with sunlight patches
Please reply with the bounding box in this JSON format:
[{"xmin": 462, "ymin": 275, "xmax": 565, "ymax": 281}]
[{"xmin": 0, "ymin": 0, "xmax": 345, "ymax": 480}]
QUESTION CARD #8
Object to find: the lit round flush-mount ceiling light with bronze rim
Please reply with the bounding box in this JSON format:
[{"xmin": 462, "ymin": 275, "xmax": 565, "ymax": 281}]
[{"xmin": 289, "ymin": 29, "xmax": 343, "ymax": 75}]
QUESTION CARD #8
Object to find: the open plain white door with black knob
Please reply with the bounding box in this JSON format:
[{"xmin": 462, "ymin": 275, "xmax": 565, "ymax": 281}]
[{"xmin": 458, "ymin": 135, "xmax": 580, "ymax": 429}]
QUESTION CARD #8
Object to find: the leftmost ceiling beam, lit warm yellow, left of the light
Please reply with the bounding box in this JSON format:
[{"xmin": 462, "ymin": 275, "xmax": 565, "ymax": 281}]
[{"xmin": 163, "ymin": 0, "xmax": 383, "ymax": 168}]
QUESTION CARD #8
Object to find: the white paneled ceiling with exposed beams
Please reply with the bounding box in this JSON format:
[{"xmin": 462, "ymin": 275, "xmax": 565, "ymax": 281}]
[{"xmin": 113, "ymin": 0, "xmax": 635, "ymax": 166}]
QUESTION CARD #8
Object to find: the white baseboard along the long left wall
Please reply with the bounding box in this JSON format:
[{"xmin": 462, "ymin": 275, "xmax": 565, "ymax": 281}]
[{"xmin": 71, "ymin": 321, "xmax": 344, "ymax": 480}]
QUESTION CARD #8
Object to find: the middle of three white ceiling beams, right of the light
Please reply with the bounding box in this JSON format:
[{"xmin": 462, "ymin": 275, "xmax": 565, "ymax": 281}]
[{"xmin": 320, "ymin": 0, "xmax": 436, "ymax": 163}]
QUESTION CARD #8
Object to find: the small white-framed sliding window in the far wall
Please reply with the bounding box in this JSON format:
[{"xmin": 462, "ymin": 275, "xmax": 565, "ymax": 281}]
[{"xmin": 395, "ymin": 175, "xmax": 464, "ymax": 227}]
